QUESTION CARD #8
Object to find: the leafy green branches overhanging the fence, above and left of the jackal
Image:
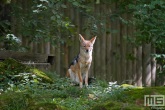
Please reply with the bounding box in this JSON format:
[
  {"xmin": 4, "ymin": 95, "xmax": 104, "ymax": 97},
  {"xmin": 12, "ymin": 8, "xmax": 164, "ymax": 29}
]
[{"xmin": 3, "ymin": 0, "xmax": 114, "ymax": 46}]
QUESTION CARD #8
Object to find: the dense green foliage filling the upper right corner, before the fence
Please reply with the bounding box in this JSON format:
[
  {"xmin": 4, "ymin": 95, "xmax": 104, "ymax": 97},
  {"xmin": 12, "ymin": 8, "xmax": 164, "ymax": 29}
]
[{"xmin": 125, "ymin": 0, "xmax": 165, "ymax": 46}]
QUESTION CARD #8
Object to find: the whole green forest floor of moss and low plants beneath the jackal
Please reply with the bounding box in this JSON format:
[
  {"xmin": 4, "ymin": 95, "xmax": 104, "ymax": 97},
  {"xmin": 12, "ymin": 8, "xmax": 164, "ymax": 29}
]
[{"xmin": 0, "ymin": 59, "xmax": 165, "ymax": 110}]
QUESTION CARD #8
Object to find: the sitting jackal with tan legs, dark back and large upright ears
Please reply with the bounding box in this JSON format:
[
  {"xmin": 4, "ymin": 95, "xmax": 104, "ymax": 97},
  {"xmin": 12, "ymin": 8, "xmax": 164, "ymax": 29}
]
[{"xmin": 67, "ymin": 34, "xmax": 96, "ymax": 88}]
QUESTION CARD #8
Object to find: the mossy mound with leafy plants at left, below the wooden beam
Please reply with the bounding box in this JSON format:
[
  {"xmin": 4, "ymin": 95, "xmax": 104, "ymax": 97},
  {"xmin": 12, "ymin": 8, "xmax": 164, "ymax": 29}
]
[{"xmin": 0, "ymin": 59, "xmax": 53, "ymax": 91}]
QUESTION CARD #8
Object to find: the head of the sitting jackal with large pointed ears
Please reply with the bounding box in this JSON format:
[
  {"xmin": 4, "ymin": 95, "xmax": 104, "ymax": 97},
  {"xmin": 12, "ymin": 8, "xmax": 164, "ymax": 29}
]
[{"xmin": 79, "ymin": 34, "xmax": 96, "ymax": 54}]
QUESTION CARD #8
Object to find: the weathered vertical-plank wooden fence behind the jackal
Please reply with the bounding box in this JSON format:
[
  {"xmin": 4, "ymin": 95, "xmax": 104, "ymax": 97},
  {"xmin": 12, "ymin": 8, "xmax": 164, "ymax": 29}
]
[{"xmin": 0, "ymin": 1, "xmax": 165, "ymax": 86}]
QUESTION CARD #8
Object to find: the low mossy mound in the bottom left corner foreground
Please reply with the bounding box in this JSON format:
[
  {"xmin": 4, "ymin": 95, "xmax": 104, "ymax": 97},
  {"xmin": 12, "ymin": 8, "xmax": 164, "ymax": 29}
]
[{"xmin": 0, "ymin": 92, "xmax": 66, "ymax": 110}]
